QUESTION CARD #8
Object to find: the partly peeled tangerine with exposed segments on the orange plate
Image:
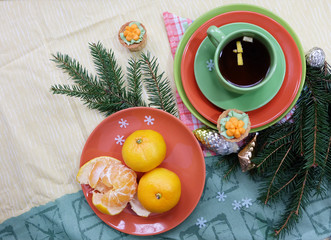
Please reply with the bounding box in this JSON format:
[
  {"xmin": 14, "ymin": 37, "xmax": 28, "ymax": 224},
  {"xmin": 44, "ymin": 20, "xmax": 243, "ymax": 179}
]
[{"xmin": 76, "ymin": 156, "xmax": 137, "ymax": 215}]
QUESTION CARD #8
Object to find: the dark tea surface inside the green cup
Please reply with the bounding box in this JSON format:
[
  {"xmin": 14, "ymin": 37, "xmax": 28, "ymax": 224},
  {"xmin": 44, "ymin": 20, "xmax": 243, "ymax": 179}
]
[{"xmin": 218, "ymin": 37, "xmax": 270, "ymax": 87}]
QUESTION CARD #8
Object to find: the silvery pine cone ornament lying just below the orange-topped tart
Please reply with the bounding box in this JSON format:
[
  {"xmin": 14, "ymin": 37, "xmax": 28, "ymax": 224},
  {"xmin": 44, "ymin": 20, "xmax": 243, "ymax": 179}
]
[{"xmin": 193, "ymin": 128, "xmax": 239, "ymax": 155}]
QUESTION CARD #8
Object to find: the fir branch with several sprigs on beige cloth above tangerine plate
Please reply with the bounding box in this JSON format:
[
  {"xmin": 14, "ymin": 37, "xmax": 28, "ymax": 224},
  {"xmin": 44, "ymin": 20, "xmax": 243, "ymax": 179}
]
[{"xmin": 51, "ymin": 42, "xmax": 178, "ymax": 116}]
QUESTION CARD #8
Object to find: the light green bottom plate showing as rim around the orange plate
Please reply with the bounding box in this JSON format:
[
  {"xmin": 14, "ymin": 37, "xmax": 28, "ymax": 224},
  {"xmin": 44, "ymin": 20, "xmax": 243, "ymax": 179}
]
[{"xmin": 174, "ymin": 4, "xmax": 306, "ymax": 132}]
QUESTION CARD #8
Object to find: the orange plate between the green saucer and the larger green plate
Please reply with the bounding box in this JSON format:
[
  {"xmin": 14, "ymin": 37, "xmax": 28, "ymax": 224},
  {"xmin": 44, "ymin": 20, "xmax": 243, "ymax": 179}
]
[{"xmin": 181, "ymin": 11, "xmax": 302, "ymax": 129}]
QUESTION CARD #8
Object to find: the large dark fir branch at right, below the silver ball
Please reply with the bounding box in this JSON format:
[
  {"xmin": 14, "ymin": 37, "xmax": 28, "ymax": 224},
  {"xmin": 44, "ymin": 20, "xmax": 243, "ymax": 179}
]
[{"xmin": 250, "ymin": 62, "xmax": 331, "ymax": 236}]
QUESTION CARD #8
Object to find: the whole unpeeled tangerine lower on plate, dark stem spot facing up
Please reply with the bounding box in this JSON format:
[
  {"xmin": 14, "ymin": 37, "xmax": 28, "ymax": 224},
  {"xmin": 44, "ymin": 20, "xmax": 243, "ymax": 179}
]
[{"xmin": 137, "ymin": 168, "xmax": 181, "ymax": 213}]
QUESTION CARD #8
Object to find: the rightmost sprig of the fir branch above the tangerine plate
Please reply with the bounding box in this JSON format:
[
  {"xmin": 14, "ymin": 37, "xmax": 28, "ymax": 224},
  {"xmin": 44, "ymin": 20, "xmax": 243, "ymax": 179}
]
[{"xmin": 141, "ymin": 52, "xmax": 178, "ymax": 116}]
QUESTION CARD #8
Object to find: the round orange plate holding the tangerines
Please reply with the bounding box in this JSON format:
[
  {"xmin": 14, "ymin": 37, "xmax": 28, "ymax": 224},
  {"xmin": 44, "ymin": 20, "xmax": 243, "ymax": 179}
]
[{"xmin": 80, "ymin": 107, "xmax": 206, "ymax": 236}]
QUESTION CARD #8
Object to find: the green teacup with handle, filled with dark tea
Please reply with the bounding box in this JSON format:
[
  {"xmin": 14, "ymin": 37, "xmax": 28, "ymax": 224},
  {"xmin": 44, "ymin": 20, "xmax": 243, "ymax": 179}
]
[{"xmin": 207, "ymin": 24, "xmax": 282, "ymax": 94}]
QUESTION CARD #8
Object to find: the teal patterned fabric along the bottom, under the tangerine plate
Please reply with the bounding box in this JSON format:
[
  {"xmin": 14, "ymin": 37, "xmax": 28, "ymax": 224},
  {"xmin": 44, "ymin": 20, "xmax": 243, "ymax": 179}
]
[{"xmin": 0, "ymin": 157, "xmax": 331, "ymax": 240}]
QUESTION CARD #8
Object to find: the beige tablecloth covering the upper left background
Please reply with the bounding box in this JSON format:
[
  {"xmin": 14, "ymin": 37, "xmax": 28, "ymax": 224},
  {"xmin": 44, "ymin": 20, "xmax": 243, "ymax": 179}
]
[{"xmin": 0, "ymin": 0, "xmax": 331, "ymax": 222}]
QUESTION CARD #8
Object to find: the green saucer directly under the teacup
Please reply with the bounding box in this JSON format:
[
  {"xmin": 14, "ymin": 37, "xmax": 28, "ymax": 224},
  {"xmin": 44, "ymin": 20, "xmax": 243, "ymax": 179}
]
[{"xmin": 194, "ymin": 23, "xmax": 286, "ymax": 112}]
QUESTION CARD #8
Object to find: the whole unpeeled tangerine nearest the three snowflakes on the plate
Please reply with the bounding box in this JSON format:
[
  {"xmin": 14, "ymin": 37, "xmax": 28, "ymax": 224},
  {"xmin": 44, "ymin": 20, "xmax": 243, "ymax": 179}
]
[{"xmin": 122, "ymin": 130, "xmax": 166, "ymax": 172}]
